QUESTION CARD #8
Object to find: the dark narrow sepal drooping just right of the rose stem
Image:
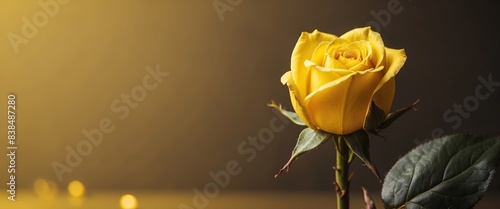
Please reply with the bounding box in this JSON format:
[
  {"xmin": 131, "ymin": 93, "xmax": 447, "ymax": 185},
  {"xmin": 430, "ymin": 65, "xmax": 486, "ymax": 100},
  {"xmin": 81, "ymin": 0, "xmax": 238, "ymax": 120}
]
[{"xmin": 342, "ymin": 130, "xmax": 382, "ymax": 182}]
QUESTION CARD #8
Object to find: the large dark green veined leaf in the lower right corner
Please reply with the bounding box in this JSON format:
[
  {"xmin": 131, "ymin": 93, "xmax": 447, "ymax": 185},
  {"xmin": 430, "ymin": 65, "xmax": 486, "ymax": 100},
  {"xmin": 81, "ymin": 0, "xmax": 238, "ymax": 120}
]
[{"xmin": 382, "ymin": 134, "xmax": 500, "ymax": 209}]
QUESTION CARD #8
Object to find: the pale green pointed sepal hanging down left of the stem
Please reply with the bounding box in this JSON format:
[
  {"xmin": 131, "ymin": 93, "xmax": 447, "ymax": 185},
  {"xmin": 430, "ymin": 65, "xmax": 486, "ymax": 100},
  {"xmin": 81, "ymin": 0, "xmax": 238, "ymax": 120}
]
[{"xmin": 274, "ymin": 128, "xmax": 332, "ymax": 178}]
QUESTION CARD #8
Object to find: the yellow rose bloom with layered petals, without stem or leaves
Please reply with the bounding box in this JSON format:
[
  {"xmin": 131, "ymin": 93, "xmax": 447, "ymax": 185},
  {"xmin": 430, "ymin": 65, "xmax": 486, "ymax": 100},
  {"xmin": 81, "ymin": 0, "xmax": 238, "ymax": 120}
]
[{"xmin": 281, "ymin": 27, "xmax": 406, "ymax": 135}]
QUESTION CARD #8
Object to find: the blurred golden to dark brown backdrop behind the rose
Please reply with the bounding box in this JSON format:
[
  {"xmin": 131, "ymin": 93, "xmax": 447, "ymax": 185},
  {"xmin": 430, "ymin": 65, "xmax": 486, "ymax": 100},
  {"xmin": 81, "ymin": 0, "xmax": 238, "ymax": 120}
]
[{"xmin": 0, "ymin": 0, "xmax": 500, "ymax": 207}]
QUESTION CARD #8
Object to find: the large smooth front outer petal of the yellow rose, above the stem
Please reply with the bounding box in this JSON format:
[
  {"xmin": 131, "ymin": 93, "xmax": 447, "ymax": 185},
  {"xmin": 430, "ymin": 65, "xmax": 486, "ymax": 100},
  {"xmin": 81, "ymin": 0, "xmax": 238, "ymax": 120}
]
[{"xmin": 304, "ymin": 69, "xmax": 383, "ymax": 135}]
